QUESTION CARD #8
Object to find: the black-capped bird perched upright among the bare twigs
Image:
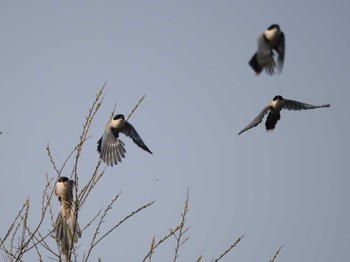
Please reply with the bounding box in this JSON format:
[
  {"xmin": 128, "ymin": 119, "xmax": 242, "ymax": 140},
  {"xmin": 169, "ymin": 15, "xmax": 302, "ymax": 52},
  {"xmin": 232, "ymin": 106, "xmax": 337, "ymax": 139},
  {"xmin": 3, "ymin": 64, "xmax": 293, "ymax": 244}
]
[{"xmin": 55, "ymin": 176, "xmax": 81, "ymax": 255}]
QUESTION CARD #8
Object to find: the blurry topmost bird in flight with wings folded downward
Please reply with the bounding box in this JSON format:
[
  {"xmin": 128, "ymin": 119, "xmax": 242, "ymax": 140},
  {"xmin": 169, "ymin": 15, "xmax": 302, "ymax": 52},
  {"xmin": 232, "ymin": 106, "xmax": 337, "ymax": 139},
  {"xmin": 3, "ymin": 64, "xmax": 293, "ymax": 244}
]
[{"xmin": 249, "ymin": 24, "xmax": 286, "ymax": 75}]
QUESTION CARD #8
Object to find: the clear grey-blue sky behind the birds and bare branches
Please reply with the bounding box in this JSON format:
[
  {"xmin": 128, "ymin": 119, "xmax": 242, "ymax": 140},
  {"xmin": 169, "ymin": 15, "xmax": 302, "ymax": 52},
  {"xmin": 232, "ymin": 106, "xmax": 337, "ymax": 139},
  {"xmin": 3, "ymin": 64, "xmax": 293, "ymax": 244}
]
[{"xmin": 0, "ymin": 0, "xmax": 350, "ymax": 262}]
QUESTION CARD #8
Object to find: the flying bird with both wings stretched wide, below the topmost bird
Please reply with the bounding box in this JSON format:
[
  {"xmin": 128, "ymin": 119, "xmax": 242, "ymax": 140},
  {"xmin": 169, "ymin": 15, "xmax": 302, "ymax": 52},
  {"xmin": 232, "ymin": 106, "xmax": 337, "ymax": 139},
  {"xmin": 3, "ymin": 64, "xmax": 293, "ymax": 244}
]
[{"xmin": 238, "ymin": 95, "xmax": 330, "ymax": 135}]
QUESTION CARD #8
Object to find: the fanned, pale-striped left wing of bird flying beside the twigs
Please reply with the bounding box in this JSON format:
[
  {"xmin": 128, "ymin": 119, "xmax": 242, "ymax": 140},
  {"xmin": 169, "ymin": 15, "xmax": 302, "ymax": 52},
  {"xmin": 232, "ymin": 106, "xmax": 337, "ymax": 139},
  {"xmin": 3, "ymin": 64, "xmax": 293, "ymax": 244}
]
[{"xmin": 97, "ymin": 126, "xmax": 126, "ymax": 166}]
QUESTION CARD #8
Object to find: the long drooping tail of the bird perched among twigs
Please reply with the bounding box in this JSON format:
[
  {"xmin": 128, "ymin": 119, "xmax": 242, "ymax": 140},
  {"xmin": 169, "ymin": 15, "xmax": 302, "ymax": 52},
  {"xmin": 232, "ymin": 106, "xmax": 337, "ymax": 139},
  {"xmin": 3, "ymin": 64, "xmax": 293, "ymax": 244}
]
[{"xmin": 55, "ymin": 206, "xmax": 81, "ymax": 255}]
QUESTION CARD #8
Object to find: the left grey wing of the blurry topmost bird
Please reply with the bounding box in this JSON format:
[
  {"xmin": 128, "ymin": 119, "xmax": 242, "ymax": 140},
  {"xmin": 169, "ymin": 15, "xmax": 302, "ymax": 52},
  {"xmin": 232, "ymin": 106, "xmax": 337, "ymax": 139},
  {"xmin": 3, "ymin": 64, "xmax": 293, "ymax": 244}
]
[{"xmin": 256, "ymin": 34, "xmax": 276, "ymax": 75}]
